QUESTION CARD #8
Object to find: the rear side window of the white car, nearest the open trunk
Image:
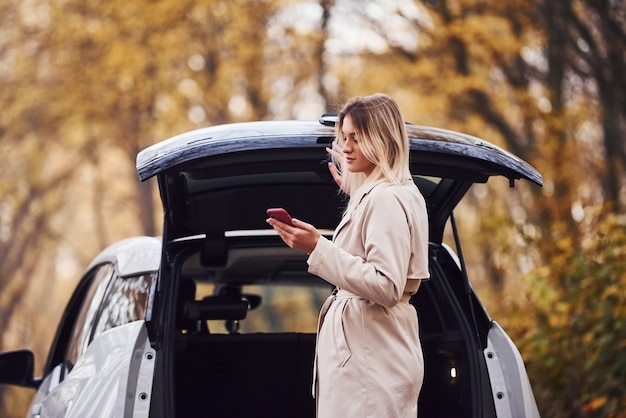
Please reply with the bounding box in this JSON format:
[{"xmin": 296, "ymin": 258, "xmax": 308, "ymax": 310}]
[{"xmin": 91, "ymin": 274, "xmax": 153, "ymax": 340}]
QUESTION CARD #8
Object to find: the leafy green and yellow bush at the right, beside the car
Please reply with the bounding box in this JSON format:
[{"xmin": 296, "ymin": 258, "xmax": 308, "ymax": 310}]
[{"xmin": 510, "ymin": 208, "xmax": 626, "ymax": 416}]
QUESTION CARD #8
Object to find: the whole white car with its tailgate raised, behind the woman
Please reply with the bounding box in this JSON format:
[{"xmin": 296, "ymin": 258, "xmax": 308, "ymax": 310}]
[{"xmin": 0, "ymin": 115, "xmax": 542, "ymax": 418}]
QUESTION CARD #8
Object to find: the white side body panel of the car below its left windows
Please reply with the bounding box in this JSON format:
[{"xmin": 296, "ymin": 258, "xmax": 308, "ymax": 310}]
[{"xmin": 30, "ymin": 321, "xmax": 156, "ymax": 418}]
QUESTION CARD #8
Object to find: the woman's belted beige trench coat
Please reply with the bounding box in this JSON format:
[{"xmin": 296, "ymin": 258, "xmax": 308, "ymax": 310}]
[{"xmin": 308, "ymin": 180, "xmax": 429, "ymax": 418}]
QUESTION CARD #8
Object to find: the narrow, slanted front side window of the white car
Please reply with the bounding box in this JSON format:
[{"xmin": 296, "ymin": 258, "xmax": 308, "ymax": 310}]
[{"xmin": 65, "ymin": 263, "xmax": 115, "ymax": 369}]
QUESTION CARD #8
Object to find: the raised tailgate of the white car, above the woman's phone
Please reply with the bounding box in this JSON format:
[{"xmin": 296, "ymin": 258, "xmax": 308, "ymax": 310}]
[{"xmin": 137, "ymin": 115, "xmax": 542, "ymax": 242}]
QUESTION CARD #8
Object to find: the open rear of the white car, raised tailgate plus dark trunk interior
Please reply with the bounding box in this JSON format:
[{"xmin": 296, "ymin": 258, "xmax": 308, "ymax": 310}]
[{"xmin": 137, "ymin": 118, "xmax": 541, "ymax": 417}]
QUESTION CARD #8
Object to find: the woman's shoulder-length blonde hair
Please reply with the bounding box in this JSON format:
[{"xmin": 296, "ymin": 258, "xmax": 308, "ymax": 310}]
[{"xmin": 335, "ymin": 93, "xmax": 411, "ymax": 196}]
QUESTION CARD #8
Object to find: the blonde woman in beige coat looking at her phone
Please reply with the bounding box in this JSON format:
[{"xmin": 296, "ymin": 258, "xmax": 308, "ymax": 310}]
[{"xmin": 267, "ymin": 94, "xmax": 429, "ymax": 418}]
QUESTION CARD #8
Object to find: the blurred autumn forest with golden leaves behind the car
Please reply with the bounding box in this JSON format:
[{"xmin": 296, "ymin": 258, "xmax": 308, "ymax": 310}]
[{"xmin": 0, "ymin": 0, "xmax": 626, "ymax": 417}]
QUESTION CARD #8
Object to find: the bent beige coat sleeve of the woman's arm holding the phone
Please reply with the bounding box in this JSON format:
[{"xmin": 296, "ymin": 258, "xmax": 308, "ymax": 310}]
[{"xmin": 309, "ymin": 192, "xmax": 411, "ymax": 307}]
